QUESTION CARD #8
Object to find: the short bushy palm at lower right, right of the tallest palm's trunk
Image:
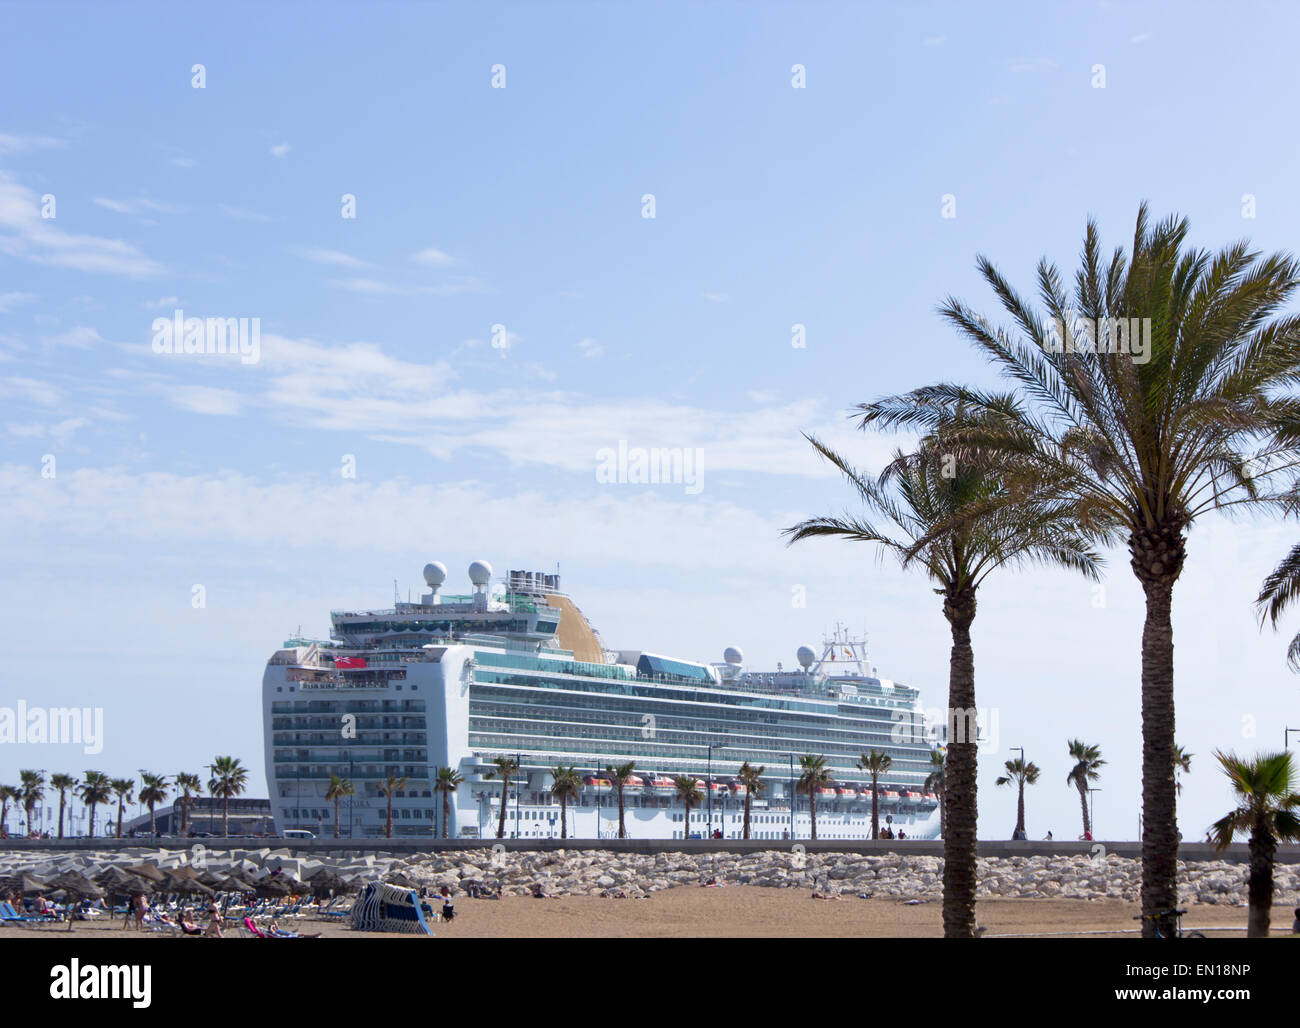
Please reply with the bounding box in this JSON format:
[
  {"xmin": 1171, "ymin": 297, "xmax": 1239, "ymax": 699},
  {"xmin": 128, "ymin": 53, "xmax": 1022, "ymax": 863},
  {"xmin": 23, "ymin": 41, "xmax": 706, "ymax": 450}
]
[{"xmin": 1210, "ymin": 751, "xmax": 1300, "ymax": 938}]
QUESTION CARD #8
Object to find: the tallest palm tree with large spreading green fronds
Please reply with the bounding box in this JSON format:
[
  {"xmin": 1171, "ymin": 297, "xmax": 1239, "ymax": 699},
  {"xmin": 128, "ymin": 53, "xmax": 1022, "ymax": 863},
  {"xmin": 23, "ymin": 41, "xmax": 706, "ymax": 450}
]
[{"xmin": 863, "ymin": 204, "xmax": 1300, "ymax": 937}]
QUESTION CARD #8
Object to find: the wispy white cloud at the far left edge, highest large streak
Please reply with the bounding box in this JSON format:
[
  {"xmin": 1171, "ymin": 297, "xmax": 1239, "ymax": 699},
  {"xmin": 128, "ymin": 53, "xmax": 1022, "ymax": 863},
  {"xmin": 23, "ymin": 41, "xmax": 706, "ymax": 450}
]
[{"xmin": 0, "ymin": 172, "xmax": 164, "ymax": 278}]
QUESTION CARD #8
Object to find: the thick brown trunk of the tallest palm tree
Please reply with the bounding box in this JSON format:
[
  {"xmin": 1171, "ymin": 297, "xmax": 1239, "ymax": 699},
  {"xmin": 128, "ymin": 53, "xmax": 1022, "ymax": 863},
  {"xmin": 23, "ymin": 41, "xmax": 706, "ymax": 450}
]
[{"xmin": 1128, "ymin": 535, "xmax": 1186, "ymax": 938}]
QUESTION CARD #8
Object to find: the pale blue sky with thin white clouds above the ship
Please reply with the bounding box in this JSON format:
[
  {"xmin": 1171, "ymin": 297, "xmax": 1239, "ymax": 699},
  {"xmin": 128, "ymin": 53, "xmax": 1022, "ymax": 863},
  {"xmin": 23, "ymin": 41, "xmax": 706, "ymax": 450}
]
[{"xmin": 0, "ymin": 3, "xmax": 1300, "ymax": 837}]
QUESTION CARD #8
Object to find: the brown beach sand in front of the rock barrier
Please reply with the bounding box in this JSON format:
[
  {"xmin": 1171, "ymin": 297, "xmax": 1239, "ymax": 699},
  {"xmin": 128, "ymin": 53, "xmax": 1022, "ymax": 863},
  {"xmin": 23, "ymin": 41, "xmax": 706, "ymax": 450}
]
[{"xmin": 0, "ymin": 885, "xmax": 1295, "ymax": 940}]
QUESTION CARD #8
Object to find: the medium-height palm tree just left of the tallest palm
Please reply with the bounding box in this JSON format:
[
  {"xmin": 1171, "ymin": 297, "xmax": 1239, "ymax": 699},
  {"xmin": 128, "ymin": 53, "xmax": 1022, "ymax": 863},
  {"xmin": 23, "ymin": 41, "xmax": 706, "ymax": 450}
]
[{"xmin": 787, "ymin": 431, "xmax": 1101, "ymax": 938}]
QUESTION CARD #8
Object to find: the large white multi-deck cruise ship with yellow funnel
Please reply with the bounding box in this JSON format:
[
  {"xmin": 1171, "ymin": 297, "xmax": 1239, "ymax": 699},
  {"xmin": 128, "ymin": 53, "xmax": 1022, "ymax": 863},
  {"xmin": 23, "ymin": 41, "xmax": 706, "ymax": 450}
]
[{"xmin": 263, "ymin": 560, "xmax": 939, "ymax": 841}]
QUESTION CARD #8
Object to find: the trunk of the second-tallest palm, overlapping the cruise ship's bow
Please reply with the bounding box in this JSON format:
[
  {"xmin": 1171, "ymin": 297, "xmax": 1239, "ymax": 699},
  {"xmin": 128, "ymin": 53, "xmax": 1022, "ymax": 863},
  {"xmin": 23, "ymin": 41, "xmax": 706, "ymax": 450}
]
[{"xmin": 944, "ymin": 589, "xmax": 979, "ymax": 938}]
